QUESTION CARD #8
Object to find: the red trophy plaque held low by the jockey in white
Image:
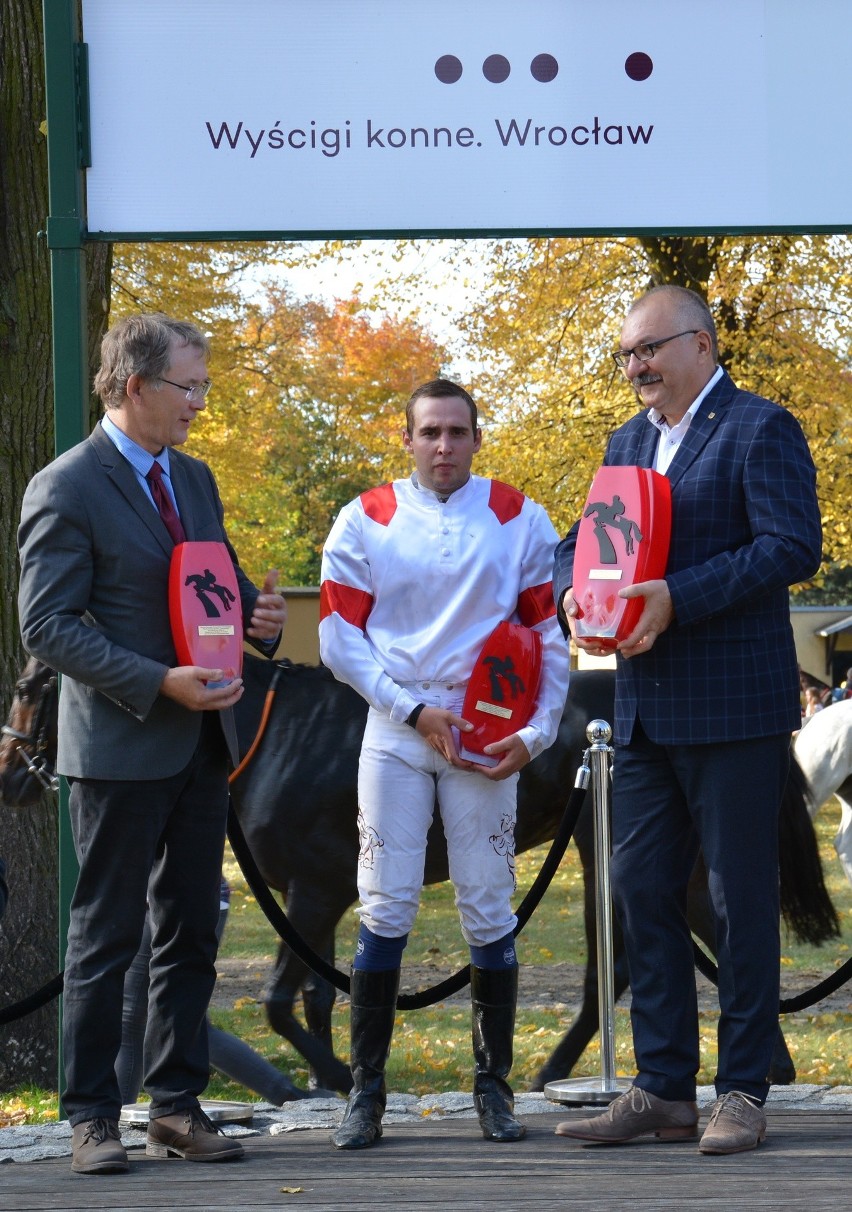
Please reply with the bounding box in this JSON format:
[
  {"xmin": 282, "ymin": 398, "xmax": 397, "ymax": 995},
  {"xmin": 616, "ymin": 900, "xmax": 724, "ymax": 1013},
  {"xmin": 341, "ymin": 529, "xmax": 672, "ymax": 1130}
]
[{"xmin": 459, "ymin": 623, "xmax": 542, "ymax": 766}]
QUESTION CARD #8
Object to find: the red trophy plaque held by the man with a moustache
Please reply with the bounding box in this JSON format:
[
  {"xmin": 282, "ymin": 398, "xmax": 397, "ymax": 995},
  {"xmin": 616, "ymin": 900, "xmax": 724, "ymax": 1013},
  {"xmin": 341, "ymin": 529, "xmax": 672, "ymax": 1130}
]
[{"xmin": 573, "ymin": 467, "xmax": 671, "ymax": 648}]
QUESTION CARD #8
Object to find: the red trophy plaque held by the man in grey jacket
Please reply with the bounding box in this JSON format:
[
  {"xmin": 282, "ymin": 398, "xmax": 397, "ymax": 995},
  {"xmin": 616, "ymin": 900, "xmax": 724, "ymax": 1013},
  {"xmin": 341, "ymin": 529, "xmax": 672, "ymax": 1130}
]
[{"xmin": 168, "ymin": 543, "xmax": 242, "ymax": 686}]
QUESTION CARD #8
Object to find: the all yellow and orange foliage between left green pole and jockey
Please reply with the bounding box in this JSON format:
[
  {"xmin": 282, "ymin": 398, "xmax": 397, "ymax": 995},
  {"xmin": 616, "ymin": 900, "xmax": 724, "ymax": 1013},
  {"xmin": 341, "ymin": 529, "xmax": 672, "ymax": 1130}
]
[{"xmin": 113, "ymin": 244, "xmax": 446, "ymax": 585}]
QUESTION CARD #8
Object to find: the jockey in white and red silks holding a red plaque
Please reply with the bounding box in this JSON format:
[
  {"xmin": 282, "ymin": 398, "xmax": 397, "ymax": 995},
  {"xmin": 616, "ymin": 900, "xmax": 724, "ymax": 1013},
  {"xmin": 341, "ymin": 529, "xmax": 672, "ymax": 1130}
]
[{"xmin": 320, "ymin": 379, "xmax": 568, "ymax": 1149}]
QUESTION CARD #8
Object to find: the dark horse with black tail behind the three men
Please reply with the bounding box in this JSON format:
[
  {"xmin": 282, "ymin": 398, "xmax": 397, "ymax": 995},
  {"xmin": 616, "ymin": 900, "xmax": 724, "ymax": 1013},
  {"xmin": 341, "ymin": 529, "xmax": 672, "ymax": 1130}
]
[{"xmin": 0, "ymin": 656, "xmax": 836, "ymax": 1091}]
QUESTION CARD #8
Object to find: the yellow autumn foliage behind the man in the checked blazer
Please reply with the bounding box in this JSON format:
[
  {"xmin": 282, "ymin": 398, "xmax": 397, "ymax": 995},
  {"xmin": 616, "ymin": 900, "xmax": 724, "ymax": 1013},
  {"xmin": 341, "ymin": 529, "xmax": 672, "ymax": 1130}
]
[{"xmin": 387, "ymin": 235, "xmax": 852, "ymax": 586}]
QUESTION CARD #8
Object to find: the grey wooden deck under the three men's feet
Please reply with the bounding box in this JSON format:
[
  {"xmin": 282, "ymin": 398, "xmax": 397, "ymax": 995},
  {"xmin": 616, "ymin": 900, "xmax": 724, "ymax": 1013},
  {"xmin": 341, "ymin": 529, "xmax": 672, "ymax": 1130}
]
[{"xmin": 0, "ymin": 1108, "xmax": 852, "ymax": 1212}]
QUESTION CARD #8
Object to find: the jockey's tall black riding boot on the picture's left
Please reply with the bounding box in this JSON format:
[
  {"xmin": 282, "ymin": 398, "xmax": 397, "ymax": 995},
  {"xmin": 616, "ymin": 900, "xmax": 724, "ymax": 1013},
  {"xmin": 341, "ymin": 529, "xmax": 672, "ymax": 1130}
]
[{"xmin": 331, "ymin": 968, "xmax": 400, "ymax": 1149}]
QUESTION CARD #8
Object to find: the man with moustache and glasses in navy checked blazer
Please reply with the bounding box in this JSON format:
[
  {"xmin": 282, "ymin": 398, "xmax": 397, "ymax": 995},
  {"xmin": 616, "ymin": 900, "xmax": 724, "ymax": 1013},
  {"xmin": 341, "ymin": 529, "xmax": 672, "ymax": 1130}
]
[{"xmin": 554, "ymin": 286, "xmax": 822, "ymax": 1154}]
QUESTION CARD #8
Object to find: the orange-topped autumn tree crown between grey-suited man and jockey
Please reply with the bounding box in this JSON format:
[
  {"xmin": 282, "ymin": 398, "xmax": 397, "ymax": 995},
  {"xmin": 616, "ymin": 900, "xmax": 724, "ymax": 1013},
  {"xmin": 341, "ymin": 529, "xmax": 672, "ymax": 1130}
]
[{"xmin": 199, "ymin": 287, "xmax": 442, "ymax": 584}]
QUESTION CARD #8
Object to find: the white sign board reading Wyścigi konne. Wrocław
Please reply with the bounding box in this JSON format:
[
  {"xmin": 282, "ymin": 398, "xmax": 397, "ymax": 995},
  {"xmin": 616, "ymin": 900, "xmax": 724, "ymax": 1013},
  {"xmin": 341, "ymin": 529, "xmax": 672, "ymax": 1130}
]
[{"xmin": 82, "ymin": 0, "xmax": 852, "ymax": 235}]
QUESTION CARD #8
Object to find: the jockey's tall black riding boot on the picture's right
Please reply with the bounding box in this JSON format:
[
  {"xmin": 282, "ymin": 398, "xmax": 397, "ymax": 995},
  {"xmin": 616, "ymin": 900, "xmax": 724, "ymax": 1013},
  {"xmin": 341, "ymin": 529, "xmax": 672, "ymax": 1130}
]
[{"xmin": 470, "ymin": 965, "xmax": 526, "ymax": 1140}]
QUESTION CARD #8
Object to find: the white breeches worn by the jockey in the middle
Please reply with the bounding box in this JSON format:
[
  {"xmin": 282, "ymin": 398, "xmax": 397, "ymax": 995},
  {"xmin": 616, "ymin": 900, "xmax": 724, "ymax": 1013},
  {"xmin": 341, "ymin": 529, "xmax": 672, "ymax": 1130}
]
[{"xmin": 358, "ymin": 682, "xmax": 518, "ymax": 947}]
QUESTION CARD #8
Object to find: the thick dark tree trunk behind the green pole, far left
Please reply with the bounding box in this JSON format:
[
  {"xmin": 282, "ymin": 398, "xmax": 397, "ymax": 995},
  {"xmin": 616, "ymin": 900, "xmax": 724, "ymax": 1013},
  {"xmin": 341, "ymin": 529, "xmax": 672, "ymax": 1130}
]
[{"xmin": 0, "ymin": 0, "xmax": 110, "ymax": 1090}]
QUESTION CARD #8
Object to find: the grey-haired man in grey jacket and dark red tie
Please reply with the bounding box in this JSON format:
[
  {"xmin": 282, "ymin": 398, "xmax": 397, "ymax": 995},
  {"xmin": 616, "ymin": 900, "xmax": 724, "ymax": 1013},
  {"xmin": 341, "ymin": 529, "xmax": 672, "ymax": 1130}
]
[{"xmin": 18, "ymin": 315, "xmax": 286, "ymax": 1173}]
